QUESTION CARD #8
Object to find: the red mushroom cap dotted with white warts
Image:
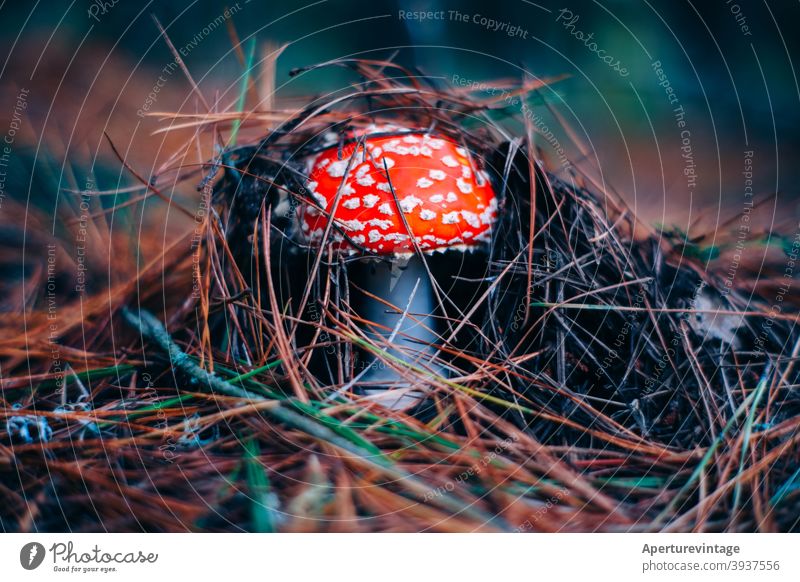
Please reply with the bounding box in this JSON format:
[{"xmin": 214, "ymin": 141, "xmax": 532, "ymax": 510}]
[{"xmin": 300, "ymin": 131, "xmax": 497, "ymax": 256}]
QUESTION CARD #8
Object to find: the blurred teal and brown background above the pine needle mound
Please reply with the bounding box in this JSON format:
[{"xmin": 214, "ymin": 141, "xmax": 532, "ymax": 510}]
[{"xmin": 0, "ymin": 0, "xmax": 800, "ymax": 228}]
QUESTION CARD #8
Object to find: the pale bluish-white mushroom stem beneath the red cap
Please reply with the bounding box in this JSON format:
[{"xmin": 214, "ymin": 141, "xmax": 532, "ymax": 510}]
[{"xmin": 356, "ymin": 256, "xmax": 445, "ymax": 410}]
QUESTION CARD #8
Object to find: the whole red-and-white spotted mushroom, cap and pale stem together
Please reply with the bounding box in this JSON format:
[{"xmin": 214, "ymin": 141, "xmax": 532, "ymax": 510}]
[{"xmin": 300, "ymin": 126, "xmax": 497, "ymax": 409}]
